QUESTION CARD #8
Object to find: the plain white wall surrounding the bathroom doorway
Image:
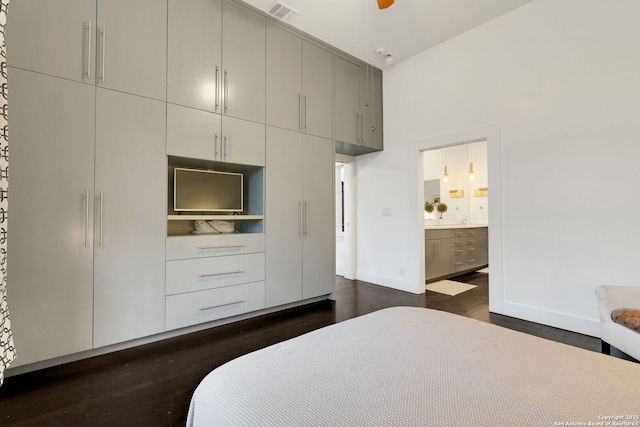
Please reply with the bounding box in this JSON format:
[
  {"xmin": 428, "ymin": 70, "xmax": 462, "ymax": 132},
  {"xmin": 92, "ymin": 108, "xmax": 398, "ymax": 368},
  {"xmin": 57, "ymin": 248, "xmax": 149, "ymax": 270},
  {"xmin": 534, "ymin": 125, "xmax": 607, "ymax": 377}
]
[{"xmin": 357, "ymin": 0, "xmax": 640, "ymax": 336}]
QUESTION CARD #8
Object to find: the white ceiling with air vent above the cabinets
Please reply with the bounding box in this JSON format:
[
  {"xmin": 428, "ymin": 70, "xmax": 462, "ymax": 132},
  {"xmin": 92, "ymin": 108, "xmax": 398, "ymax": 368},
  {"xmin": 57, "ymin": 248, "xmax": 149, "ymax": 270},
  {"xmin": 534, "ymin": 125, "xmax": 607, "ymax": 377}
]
[{"xmin": 243, "ymin": 0, "xmax": 532, "ymax": 68}]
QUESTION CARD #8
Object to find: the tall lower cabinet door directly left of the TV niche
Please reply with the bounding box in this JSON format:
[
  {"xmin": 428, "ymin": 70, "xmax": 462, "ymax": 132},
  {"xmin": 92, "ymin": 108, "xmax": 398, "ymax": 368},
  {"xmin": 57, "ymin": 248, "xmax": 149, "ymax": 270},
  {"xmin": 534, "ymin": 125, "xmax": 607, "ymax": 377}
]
[{"xmin": 94, "ymin": 89, "xmax": 167, "ymax": 347}]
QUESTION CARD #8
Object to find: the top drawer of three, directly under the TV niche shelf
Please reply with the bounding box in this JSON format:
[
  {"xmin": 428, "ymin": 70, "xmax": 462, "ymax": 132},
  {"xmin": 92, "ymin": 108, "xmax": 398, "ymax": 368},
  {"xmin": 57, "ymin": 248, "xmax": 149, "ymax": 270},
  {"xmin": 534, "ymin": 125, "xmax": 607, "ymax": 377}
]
[{"xmin": 166, "ymin": 233, "xmax": 264, "ymax": 260}]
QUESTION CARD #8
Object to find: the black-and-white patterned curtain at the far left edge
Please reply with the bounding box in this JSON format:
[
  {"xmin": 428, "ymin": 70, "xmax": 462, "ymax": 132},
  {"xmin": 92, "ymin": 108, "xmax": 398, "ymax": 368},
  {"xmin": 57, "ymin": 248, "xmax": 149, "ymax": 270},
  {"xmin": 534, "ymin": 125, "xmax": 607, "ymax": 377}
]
[{"xmin": 0, "ymin": 0, "xmax": 16, "ymax": 385}]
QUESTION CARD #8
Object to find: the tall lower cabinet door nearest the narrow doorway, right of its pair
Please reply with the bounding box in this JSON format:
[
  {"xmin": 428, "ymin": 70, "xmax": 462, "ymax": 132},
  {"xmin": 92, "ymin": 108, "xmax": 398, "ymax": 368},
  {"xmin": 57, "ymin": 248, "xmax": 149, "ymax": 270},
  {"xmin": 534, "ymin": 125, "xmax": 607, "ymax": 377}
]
[{"xmin": 302, "ymin": 135, "xmax": 336, "ymax": 299}]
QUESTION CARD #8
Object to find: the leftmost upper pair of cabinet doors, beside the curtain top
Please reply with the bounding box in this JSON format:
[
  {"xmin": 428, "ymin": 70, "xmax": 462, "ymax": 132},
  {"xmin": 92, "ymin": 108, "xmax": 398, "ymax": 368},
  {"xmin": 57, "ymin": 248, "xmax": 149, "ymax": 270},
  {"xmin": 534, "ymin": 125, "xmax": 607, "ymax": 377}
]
[{"xmin": 7, "ymin": 0, "xmax": 167, "ymax": 100}]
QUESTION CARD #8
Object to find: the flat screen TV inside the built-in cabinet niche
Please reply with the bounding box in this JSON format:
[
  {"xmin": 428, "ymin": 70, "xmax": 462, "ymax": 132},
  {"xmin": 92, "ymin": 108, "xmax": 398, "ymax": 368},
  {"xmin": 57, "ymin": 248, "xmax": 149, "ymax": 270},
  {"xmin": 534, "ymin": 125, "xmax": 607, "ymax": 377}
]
[{"xmin": 173, "ymin": 168, "xmax": 243, "ymax": 212}]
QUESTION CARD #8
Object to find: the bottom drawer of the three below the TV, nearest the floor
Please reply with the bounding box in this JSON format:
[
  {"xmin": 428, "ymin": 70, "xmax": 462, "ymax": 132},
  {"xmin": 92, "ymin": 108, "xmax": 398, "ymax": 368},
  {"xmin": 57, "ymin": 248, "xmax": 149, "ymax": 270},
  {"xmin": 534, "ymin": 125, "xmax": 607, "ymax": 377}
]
[{"xmin": 166, "ymin": 282, "xmax": 265, "ymax": 331}]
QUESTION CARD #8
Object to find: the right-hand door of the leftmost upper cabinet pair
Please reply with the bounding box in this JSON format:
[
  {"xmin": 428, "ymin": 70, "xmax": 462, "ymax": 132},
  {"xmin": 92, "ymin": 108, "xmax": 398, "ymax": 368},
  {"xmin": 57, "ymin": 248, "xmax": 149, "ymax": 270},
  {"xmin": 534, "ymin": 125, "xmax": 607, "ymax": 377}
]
[{"xmin": 96, "ymin": 0, "xmax": 167, "ymax": 100}]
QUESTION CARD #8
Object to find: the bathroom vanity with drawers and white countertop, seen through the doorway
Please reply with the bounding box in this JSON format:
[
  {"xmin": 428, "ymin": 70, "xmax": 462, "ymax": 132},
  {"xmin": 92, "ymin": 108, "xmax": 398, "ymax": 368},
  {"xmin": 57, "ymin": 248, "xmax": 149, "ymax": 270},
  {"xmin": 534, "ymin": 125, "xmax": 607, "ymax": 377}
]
[{"xmin": 424, "ymin": 225, "xmax": 489, "ymax": 282}]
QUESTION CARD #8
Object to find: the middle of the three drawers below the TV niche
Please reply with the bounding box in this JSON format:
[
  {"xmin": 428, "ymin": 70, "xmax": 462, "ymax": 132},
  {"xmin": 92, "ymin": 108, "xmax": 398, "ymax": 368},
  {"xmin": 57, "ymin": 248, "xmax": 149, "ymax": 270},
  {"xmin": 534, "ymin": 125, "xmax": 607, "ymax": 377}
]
[{"xmin": 166, "ymin": 252, "xmax": 265, "ymax": 295}]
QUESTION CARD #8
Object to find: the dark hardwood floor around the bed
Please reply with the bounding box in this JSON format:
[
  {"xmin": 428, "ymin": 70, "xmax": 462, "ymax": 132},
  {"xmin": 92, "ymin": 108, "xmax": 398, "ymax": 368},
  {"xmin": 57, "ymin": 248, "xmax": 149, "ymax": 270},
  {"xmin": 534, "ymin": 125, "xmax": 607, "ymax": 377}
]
[{"xmin": 0, "ymin": 273, "xmax": 616, "ymax": 427}]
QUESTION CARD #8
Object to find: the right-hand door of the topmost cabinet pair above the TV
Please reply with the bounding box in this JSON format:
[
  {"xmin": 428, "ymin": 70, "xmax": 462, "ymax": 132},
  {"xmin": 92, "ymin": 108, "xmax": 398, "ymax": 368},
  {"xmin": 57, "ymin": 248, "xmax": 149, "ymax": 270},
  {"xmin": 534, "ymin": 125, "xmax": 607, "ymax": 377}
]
[{"xmin": 222, "ymin": 2, "xmax": 265, "ymax": 123}]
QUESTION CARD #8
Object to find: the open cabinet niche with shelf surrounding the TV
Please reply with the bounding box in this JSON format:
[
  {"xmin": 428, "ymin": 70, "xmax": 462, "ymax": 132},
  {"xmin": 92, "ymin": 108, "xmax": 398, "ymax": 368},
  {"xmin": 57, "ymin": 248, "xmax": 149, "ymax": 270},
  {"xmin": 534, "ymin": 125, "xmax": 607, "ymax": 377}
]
[{"xmin": 167, "ymin": 156, "xmax": 264, "ymax": 236}]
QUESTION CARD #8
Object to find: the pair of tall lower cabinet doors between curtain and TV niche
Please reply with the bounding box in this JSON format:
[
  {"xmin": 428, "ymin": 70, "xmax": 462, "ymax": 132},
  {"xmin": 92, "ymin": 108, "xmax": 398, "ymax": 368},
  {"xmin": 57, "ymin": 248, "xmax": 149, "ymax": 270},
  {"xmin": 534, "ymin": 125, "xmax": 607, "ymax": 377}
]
[{"xmin": 9, "ymin": 68, "xmax": 166, "ymax": 364}]
